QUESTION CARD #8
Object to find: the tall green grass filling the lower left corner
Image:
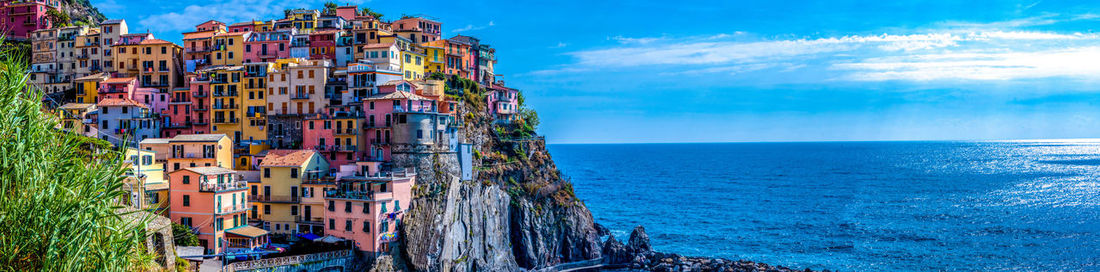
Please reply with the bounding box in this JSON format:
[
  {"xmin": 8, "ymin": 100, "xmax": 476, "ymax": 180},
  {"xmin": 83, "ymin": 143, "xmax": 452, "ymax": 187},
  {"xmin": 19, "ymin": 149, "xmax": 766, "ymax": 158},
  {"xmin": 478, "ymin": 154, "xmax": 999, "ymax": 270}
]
[{"xmin": 0, "ymin": 37, "xmax": 155, "ymax": 271}]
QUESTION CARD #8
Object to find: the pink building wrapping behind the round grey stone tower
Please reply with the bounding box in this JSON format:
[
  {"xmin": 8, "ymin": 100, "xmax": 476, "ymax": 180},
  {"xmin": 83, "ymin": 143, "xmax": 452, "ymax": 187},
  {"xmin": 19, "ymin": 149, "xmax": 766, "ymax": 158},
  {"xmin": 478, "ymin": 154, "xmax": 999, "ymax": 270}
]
[{"xmin": 363, "ymin": 80, "xmax": 437, "ymax": 161}]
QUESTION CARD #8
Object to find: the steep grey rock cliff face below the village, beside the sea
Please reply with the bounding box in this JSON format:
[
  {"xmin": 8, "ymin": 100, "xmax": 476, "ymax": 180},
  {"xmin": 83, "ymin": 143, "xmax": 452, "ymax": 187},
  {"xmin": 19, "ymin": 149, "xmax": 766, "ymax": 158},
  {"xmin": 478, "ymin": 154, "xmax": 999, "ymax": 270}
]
[{"xmin": 395, "ymin": 90, "xmax": 601, "ymax": 271}]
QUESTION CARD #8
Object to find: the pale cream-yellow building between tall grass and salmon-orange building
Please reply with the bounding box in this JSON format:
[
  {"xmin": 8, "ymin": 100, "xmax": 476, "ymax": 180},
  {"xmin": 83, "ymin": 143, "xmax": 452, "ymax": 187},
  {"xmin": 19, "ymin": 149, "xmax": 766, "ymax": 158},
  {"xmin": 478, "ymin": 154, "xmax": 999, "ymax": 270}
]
[{"xmin": 123, "ymin": 148, "xmax": 168, "ymax": 214}]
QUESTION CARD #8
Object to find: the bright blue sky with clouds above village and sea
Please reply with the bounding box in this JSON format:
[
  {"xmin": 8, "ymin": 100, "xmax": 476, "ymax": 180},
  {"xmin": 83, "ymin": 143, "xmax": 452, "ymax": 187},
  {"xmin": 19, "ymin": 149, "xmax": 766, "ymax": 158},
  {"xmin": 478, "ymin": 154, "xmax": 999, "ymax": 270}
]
[{"xmin": 91, "ymin": 0, "xmax": 1100, "ymax": 143}]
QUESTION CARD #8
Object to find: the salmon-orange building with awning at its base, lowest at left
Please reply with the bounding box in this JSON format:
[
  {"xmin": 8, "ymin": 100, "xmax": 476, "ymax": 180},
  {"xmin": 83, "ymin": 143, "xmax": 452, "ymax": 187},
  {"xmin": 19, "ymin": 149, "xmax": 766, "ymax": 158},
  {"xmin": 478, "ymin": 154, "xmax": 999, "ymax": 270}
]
[{"xmin": 168, "ymin": 167, "xmax": 267, "ymax": 253}]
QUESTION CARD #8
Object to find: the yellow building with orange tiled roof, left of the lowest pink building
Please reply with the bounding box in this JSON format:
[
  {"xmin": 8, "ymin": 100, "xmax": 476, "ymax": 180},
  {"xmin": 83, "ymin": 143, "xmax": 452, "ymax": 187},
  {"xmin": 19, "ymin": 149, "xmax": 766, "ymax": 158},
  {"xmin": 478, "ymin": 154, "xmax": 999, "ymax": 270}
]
[{"xmin": 249, "ymin": 150, "xmax": 329, "ymax": 233}]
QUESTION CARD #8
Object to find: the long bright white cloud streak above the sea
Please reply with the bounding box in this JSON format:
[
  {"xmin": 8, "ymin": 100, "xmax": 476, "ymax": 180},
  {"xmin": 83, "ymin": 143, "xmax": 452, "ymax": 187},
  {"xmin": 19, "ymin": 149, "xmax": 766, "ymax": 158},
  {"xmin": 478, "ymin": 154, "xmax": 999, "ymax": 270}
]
[{"xmin": 541, "ymin": 26, "xmax": 1100, "ymax": 81}]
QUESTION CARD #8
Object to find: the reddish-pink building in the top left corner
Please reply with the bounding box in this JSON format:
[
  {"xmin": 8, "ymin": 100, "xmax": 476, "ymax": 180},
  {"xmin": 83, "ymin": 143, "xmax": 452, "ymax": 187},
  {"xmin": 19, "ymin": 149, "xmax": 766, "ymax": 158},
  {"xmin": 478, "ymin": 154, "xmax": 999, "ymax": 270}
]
[{"xmin": 0, "ymin": 0, "xmax": 61, "ymax": 40}]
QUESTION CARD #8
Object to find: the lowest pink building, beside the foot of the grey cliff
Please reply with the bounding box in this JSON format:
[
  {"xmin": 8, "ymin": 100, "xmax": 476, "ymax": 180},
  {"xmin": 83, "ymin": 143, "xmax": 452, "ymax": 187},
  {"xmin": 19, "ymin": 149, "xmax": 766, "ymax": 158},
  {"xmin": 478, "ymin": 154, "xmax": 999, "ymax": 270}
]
[{"xmin": 325, "ymin": 165, "xmax": 416, "ymax": 252}]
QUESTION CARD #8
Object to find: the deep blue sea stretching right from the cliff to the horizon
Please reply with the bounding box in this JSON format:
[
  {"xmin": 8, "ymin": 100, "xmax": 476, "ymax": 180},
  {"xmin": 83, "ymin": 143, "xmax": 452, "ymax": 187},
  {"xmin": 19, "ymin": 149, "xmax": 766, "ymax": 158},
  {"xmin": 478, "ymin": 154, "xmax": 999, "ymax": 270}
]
[{"xmin": 549, "ymin": 140, "xmax": 1100, "ymax": 271}]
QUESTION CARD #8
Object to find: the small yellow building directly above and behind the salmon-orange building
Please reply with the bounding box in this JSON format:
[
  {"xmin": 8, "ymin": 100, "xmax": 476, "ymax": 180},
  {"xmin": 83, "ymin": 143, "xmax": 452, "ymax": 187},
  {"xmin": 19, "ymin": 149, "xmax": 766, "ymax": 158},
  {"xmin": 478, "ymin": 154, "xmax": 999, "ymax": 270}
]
[{"xmin": 167, "ymin": 134, "xmax": 233, "ymax": 172}]
